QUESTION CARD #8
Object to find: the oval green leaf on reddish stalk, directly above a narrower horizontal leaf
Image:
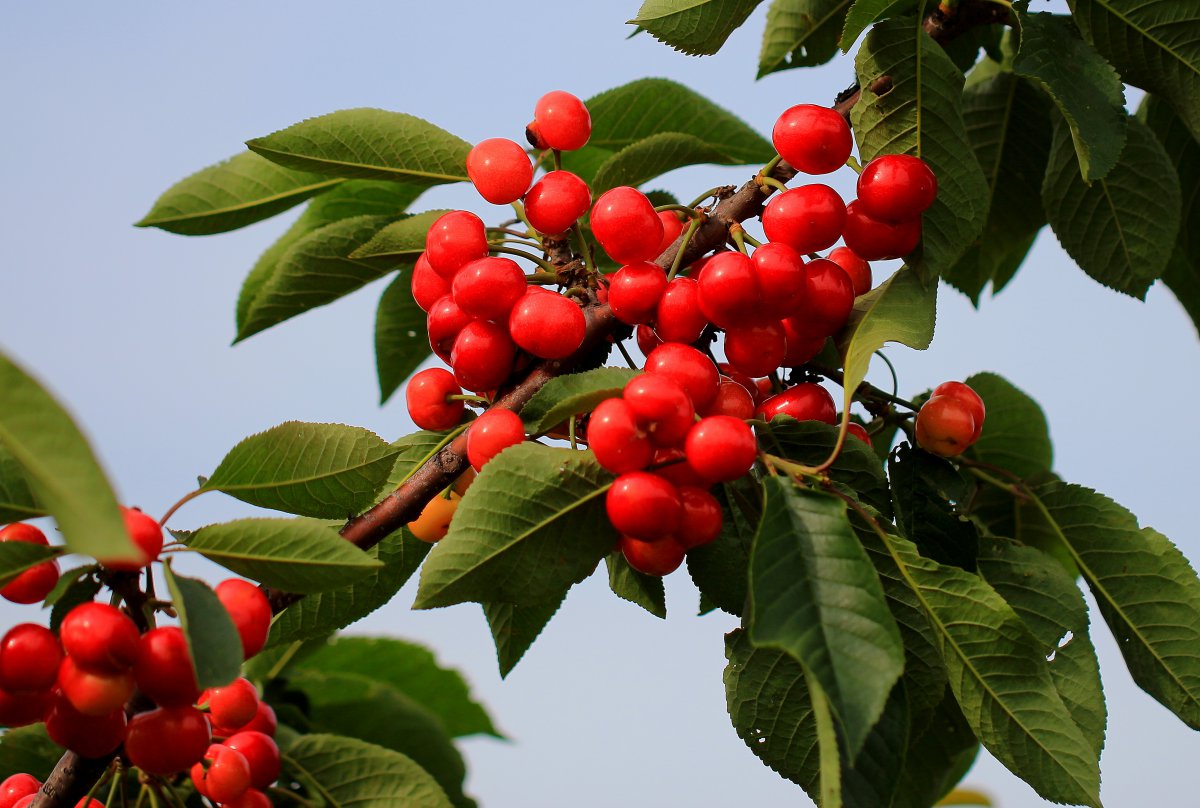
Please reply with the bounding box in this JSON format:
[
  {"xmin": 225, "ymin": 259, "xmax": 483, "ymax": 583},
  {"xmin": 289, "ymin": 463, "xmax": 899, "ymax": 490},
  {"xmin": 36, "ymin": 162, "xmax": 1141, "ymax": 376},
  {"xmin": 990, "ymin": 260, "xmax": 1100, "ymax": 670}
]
[{"xmin": 204, "ymin": 421, "xmax": 396, "ymax": 519}]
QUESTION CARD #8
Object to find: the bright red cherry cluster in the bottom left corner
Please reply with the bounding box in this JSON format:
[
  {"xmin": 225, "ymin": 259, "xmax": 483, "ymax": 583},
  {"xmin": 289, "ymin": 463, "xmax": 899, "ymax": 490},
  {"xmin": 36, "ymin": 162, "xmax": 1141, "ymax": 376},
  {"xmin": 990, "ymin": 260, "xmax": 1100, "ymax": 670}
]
[{"xmin": 0, "ymin": 521, "xmax": 280, "ymax": 808}]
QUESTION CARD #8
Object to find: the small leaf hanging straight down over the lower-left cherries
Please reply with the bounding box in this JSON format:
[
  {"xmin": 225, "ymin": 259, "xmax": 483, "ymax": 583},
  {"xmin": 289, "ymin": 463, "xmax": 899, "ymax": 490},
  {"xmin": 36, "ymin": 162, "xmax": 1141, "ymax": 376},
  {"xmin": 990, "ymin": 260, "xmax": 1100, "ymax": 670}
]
[{"xmin": 163, "ymin": 563, "xmax": 242, "ymax": 689}]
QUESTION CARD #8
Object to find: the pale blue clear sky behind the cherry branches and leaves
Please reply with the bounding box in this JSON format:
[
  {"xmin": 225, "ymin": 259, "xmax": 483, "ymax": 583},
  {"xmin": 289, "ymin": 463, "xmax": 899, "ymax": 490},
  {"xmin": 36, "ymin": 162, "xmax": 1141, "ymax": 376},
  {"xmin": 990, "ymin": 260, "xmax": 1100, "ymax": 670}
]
[{"xmin": 0, "ymin": 0, "xmax": 1200, "ymax": 808}]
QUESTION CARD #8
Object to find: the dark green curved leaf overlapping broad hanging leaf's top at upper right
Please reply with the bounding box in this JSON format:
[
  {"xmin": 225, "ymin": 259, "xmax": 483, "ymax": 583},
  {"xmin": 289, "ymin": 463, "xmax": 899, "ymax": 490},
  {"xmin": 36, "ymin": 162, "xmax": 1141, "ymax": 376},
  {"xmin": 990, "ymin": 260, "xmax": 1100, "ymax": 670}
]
[{"xmin": 1013, "ymin": 12, "xmax": 1128, "ymax": 181}]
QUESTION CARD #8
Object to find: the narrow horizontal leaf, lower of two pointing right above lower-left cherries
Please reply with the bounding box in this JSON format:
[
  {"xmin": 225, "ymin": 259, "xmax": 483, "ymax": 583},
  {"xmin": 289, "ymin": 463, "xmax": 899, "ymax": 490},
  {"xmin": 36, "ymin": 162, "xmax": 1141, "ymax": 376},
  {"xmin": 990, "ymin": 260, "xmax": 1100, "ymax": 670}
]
[{"xmin": 181, "ymin": 519, "xmax": 383, "ymax": 594}]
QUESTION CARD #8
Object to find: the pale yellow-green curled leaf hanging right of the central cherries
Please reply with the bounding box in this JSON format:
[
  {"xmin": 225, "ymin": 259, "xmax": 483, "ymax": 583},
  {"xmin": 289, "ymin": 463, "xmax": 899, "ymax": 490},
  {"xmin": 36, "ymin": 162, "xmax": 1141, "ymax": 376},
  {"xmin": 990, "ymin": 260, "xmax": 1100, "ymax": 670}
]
[{"xmin": 838, "ymin": 267, "xmax": 937, "ymax": 409}]
